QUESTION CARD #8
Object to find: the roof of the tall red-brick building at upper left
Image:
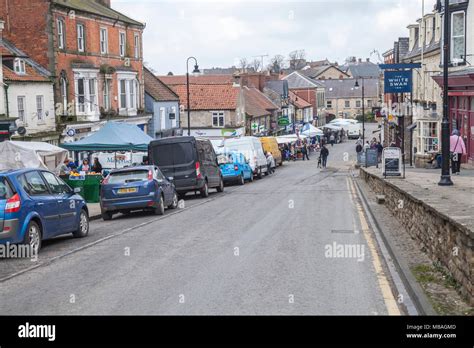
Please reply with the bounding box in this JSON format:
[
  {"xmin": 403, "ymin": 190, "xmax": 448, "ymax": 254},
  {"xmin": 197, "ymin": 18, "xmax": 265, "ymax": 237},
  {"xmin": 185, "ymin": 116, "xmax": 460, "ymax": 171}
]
[{"xmin": 51, "ymin": 0, "xmax": 145, "ymax": 27}]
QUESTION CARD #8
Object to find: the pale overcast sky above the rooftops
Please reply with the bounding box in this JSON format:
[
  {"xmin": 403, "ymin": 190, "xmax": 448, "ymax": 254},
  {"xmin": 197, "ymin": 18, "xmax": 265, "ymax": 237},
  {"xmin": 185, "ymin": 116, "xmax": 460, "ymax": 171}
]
[{"xmin": 112, "ymin": 0, "xmax": 435, "ymax": 75}]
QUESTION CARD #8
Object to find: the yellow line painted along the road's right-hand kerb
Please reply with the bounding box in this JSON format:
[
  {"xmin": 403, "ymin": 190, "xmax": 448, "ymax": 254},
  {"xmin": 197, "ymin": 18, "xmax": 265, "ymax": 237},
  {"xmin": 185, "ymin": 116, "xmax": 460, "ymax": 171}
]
[{"xmin": 347, "ymin": 178, "xmax": 401, "ymax": 315}]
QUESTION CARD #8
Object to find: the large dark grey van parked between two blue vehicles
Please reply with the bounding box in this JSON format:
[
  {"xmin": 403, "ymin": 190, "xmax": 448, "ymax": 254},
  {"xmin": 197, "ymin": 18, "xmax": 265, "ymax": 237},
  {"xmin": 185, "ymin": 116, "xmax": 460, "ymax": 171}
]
[{"xmin": 148, "ymin": 137, "xmax": 224, "ymax": 197}]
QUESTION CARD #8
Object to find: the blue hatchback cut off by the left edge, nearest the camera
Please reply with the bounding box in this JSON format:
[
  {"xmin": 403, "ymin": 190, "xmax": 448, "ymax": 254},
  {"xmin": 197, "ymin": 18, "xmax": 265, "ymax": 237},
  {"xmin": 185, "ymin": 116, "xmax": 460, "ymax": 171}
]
[{"xmin": 0, "ymin": 169, "xmax": 89, "ymax": 252}]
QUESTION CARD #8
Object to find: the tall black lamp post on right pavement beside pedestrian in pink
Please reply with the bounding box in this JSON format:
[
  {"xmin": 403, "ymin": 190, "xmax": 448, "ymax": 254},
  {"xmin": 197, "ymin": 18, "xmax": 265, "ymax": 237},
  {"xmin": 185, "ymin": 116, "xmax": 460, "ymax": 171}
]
[{"xmin": 438, "ymin": 0, "xmax": 453, "ymax": 186}]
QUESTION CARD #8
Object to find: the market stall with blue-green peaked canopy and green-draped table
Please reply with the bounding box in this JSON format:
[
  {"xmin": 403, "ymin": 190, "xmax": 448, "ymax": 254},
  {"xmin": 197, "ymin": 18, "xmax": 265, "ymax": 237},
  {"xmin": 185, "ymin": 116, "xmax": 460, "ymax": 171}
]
[{"xmin": 61, "ymin": 122, "xmax": 153, "ymax": 203}]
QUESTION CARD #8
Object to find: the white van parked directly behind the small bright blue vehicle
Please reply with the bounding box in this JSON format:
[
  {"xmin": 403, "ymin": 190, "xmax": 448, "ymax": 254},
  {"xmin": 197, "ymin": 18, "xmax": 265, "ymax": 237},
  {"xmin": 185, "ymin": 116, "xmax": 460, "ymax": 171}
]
[{"xmin": 224, "ymin": 137, "xmax": 268, "ymax": 178}]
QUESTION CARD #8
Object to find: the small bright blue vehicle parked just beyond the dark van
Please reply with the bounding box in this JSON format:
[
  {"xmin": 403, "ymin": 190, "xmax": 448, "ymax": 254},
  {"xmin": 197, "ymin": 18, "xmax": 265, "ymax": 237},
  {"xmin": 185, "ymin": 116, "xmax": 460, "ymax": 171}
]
[{"xmin": 219, "ymin": 152, "xmax": 253, "ymax": 185}]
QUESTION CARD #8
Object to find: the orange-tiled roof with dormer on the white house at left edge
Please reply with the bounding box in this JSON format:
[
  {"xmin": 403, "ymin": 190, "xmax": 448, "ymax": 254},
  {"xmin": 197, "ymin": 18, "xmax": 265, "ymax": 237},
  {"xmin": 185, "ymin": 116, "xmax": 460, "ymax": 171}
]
[{"xmin": 0, "ymin": 39, "xmax": 51, "ymax": 82}]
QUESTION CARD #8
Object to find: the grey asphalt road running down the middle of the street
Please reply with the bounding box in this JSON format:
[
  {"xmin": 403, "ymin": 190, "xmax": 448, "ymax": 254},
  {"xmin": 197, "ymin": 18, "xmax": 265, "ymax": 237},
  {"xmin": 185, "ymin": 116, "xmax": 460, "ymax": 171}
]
[{"xmin": 0, "ymin": 129, "xmax": 399, "ymax": 315}]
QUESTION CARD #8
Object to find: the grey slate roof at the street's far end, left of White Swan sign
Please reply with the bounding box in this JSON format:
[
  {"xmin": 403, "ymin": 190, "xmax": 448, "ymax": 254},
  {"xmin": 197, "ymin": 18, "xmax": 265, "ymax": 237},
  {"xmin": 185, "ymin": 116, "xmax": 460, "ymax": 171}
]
[{"xmin": 322, "ymin": 79, "xmax": 379, "ymax": 99}]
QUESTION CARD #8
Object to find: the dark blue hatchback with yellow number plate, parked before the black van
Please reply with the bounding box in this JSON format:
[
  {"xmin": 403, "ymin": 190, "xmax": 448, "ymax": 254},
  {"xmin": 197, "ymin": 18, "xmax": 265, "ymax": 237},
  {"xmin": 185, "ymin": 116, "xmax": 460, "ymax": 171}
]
[{"xmin": 100, "ymin": 165, "xmax": 178, "ymax": 220}]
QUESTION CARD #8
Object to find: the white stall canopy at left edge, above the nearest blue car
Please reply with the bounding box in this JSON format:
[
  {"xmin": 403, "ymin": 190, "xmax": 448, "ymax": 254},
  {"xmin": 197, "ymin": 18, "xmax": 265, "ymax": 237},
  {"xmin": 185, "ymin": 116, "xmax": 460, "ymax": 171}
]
[{"xmin": 0, "ymin": 141, "xmax": 68, "ymax": 171}]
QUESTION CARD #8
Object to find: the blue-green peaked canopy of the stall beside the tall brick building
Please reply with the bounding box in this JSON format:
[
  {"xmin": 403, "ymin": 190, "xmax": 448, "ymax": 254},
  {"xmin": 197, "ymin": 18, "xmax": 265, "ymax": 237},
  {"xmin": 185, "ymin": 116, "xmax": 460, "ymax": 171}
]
[{"xmin": 61, "ymin": 122, "xmax": 153, "ymax": 151}]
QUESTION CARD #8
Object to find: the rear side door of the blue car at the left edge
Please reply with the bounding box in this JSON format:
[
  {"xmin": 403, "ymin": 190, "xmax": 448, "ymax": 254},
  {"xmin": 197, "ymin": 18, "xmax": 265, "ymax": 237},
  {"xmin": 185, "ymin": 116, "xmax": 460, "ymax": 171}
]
[{"xmin": 19, "ymin": 170, "xmax": 60, "ymax": 238}]
